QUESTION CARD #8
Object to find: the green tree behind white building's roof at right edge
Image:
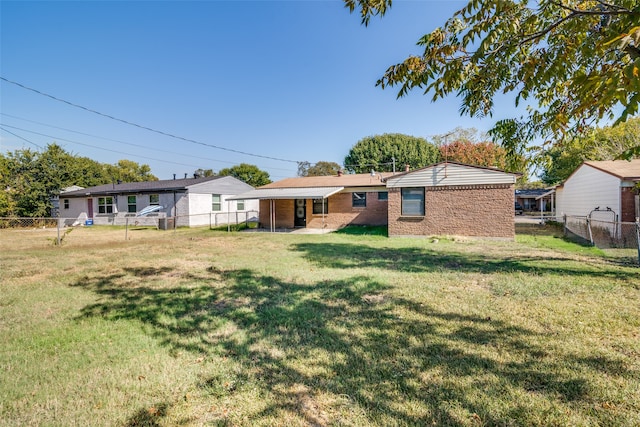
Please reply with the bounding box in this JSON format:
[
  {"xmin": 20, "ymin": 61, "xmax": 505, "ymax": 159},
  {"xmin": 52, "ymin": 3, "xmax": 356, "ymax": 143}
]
[{"xmin": 540, "ymin": 118, "xmax": 640, "ymax": 185}]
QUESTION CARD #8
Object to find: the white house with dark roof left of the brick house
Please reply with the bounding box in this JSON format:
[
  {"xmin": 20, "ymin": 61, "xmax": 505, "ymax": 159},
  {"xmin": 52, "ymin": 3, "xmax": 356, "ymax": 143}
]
[{"xmin": 59, "ymin": 176, "xmax": 258, "ymax": 227}]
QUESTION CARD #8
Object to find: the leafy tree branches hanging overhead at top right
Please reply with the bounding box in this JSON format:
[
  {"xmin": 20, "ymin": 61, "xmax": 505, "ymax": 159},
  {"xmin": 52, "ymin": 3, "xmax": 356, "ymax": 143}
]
[{"xmin": 345, "ymin": 0, "xmax": 640, "ymax": 158}]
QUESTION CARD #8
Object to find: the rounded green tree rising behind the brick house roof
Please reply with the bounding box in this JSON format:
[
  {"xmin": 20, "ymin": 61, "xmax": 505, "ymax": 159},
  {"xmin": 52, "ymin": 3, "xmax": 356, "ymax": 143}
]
[{"xmin": 344, "ymin": 133, "xmax": 440, "ymax": 173}]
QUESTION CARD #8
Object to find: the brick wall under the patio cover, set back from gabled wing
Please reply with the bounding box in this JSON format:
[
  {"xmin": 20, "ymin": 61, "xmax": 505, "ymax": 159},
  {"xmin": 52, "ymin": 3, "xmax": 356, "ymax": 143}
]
[{"xmin": 260, "ymin": 191, "xmax": 387, "ymax": 228}]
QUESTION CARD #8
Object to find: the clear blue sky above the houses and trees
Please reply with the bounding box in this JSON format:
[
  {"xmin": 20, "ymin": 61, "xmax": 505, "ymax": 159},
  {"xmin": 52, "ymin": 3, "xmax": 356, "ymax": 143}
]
[{"xmin": 0, "ymin": 0, "xmax": 513, "ymax": 180}]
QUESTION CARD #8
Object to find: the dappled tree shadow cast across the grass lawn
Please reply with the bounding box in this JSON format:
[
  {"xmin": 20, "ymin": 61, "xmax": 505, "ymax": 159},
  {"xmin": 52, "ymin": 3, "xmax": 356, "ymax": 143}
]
[{"xmin": 70, "ymin": 262, "xmax": 634, "ymax": 426}]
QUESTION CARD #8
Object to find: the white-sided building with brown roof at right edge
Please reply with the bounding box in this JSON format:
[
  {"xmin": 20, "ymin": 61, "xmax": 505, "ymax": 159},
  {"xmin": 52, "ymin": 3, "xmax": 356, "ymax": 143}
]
[{"xmin": 556, "ymin": 159, "xmax": 640, "ymax": 222}]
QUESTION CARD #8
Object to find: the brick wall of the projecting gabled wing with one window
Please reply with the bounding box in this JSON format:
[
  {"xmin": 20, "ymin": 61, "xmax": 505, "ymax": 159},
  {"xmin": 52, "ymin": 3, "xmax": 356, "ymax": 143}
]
[{"xmin": 389, "ymin": 185, "xmax": 515, "ymax": 239}]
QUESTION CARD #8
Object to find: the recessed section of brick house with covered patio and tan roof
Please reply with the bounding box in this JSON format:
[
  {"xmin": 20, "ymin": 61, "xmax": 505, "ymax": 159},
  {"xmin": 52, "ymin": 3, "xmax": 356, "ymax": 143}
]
[{"xmin": 228, "ymin": 173, "xmax": 391, "ymax": 229}]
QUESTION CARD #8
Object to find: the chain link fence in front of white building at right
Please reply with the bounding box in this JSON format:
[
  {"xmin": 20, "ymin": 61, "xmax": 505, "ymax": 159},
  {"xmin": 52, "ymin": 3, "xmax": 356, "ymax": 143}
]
[{"xmin": 563, "ymin": 215, "xmax": 640, "ymax": 264}]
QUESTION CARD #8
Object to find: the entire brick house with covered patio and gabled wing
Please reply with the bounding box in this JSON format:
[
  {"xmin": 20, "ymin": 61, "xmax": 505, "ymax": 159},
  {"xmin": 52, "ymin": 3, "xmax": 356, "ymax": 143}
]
[{"xmin": 231, "ymin": 162, "xmax": 517, "ymax": 239}]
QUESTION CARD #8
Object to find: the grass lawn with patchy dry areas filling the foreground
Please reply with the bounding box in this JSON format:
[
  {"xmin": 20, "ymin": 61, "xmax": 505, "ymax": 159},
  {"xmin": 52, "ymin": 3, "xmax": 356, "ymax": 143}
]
[{"xmin": 0, "ymin": 227, "xmax": 640, "ymax": 426}]
